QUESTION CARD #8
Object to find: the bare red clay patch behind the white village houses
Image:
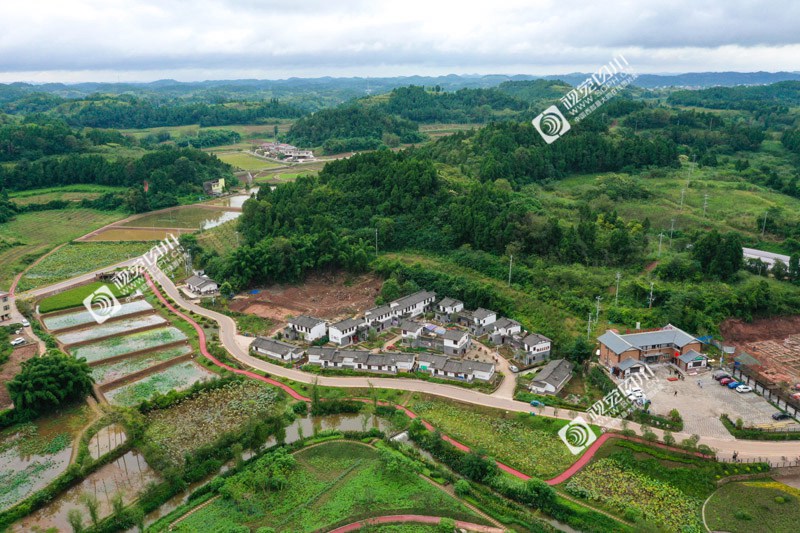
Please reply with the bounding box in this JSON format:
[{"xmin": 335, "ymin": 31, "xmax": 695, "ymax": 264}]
[{"xmin": 230, "ymin": 273, "xmax": 382, "ymax": 322}]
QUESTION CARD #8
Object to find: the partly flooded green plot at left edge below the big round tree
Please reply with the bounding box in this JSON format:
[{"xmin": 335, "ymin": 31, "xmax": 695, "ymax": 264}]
[{"xmin": 0, "ymin": 407, "xmax": 88, "ymax": 510}]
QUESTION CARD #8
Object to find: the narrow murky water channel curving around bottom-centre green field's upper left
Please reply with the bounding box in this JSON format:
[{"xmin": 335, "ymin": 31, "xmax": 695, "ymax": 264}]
[{"xmin": 145, "ymin": 414, "xmax": 390, "ymax": 525}]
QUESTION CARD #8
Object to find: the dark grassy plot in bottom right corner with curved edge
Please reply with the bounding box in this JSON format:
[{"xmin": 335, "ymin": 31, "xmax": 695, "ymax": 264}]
[{"xmin": 706, "ymin": 480, "xmax": 800, "ymax": 533}]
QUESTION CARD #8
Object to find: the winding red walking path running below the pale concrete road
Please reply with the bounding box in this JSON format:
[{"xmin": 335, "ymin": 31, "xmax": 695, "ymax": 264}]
[{"xmin": 145, "ymin": 274, "xmax": 702, "ymax": 486}]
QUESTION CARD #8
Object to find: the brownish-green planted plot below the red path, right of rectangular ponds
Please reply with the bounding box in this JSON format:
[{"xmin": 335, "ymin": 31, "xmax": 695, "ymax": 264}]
[{"xmin": 144, "ymin": 380, "xmax": 284, "ymax": 465}]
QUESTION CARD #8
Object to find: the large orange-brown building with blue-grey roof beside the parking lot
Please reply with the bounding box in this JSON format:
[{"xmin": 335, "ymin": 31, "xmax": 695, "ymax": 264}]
[{"xmin": 597, "ymin": 324, "xmax": 703, "ymax": 373}]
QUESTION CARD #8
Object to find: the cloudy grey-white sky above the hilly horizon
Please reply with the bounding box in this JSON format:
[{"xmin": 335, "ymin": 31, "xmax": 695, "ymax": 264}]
[{"xmin": 0, "ymin": 0, "xmax": 800, "ymax": 82}]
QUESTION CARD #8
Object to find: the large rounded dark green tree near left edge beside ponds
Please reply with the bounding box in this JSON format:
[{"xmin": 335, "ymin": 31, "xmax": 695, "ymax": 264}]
[{"xmin": 6, "ymin": 350, "xmax": 94, "ymax": 416}]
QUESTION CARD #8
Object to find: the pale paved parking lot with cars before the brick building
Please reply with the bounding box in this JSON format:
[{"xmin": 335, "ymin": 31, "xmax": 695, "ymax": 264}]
[{"xmin": 644, "ymin": 365, "xmax": 800, "ymax": 438}]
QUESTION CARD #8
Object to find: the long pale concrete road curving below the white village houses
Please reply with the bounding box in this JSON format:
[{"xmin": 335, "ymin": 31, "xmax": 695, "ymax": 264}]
[{"xmin": 144, "ymin": 272, "xmax": 800, "ymax": 462}]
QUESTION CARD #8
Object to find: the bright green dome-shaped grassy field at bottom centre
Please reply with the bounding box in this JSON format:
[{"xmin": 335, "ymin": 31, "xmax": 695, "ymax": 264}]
[{"xmin": 172, "ymin": 441, "xmax": 484, "ymax": 532}]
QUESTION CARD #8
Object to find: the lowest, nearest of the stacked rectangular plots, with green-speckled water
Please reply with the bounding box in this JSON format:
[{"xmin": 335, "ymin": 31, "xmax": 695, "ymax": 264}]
[{"xmin": 103, "ymin": 361, "xmax": 217, "ymax": 407}]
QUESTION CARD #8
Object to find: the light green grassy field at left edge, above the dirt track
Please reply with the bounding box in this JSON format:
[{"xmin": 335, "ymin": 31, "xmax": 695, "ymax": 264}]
[{"xmin": 0, "ymin": 209, "xmax": 125, "ymax": 289}]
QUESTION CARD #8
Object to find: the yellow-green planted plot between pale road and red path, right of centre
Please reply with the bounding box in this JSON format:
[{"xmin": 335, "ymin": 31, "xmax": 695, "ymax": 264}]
[{"xmin": 409, "ymin": 394, "xmax": 576, "ymax": 478}]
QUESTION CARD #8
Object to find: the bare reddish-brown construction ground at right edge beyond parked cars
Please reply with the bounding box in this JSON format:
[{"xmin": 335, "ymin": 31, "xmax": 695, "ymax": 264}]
[{"xmin": 720, "ymin": 316, "xmax": 800, "ymax": 385}]
